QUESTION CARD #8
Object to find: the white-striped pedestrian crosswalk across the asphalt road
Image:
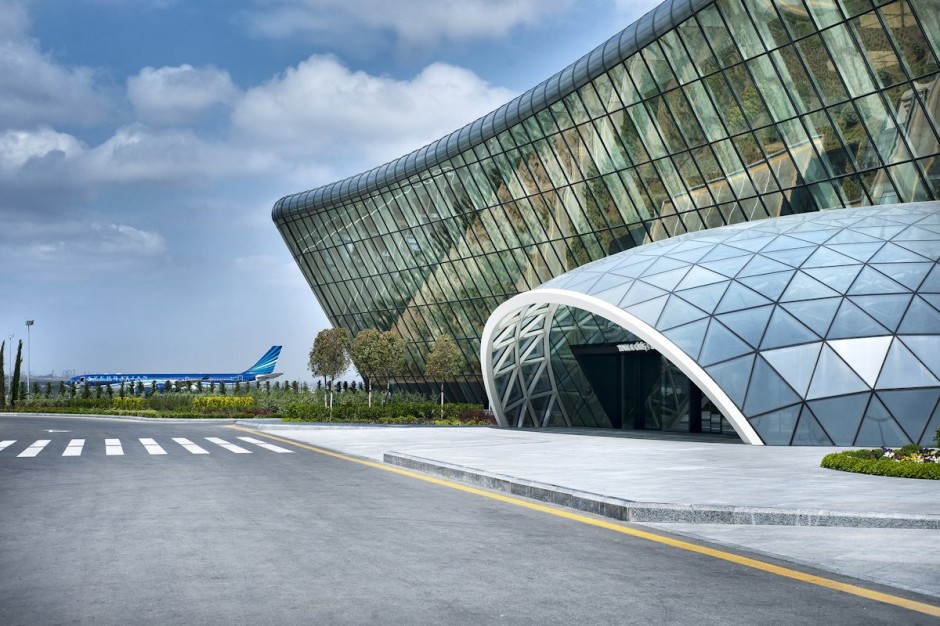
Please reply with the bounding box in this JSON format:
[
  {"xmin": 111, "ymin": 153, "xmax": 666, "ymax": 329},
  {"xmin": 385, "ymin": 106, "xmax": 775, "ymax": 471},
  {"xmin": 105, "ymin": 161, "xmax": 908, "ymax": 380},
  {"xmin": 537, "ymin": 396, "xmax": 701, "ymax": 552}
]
[{"xmin": 0, "ymin": 437, "xmax": 293, "ymax": 458}]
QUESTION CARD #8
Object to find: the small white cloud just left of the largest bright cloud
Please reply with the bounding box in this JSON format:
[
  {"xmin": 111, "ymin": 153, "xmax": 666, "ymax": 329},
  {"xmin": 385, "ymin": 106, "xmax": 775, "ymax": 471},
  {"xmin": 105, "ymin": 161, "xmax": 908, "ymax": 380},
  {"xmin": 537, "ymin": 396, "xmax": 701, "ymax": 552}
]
[{"xmin": 127, "ymin": 65, "xmax": 238, "ymax": 124}]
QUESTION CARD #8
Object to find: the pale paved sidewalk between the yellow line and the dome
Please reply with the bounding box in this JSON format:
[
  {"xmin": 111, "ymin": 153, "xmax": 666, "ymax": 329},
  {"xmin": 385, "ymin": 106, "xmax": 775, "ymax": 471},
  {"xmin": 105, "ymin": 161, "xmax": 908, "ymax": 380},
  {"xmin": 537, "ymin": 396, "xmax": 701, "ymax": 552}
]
[{"xmin": 240, "ymin": 421, "xmax": 940, "ymax": 598}]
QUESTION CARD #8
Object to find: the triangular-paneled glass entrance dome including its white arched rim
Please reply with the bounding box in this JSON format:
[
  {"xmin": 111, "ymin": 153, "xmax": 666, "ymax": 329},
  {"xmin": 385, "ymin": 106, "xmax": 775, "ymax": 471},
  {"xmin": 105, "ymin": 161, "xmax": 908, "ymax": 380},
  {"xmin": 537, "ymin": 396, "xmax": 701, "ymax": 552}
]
[{"xmin": 481, "ymin": 202, "xmax": 940, "ymax": 446}]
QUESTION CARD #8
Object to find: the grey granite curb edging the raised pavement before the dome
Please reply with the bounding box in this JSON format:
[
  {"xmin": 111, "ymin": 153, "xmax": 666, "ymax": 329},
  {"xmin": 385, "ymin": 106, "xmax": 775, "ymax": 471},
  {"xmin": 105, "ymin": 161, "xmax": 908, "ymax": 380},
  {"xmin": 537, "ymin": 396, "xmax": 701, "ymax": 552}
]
[{"xmin": 383, "ymin": 452, "xmax": 940, "ymax": 530}]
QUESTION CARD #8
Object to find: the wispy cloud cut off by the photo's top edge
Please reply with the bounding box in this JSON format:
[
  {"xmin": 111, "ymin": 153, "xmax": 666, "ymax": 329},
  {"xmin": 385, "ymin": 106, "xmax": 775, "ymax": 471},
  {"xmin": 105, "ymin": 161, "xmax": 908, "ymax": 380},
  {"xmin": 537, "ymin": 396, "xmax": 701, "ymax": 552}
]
[{"xmin": 247, "ymin": 0, "xmax": 572, "ymax": 46}]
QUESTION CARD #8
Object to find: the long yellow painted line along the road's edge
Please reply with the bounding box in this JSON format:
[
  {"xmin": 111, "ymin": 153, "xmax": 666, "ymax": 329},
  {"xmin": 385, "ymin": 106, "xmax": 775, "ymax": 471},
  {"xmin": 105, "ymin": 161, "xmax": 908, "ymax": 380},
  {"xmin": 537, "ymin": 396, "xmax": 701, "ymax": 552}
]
[{"xmin": 227, "ymin": 426, "xmax": 940, "ymax": 617}]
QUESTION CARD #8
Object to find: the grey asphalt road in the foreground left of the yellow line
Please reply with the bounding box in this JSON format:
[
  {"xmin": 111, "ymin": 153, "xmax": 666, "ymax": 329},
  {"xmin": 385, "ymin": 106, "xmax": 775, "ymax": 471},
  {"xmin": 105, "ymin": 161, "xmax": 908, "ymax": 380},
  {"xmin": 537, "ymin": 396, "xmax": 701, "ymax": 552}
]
[{"xmin": 0, "ymin": 417, "xmax": 936, "ymax": 625}]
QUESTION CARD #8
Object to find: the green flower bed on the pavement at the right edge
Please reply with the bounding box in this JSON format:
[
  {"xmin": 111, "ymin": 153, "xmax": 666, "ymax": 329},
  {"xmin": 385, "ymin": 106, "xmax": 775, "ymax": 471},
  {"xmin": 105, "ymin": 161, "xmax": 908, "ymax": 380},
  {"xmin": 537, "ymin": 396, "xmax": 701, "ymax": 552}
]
[{"xmin": 820, "ymin": 444, "xmax": 940, "ymax": 480}]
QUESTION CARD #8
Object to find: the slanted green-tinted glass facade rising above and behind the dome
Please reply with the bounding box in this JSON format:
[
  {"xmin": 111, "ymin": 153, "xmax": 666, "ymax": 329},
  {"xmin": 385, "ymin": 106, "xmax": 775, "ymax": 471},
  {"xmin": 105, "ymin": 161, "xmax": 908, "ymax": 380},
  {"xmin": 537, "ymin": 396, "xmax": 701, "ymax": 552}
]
[{"xmin": 274, "ymin": 0, "xmax": 940, "ymax": 404}]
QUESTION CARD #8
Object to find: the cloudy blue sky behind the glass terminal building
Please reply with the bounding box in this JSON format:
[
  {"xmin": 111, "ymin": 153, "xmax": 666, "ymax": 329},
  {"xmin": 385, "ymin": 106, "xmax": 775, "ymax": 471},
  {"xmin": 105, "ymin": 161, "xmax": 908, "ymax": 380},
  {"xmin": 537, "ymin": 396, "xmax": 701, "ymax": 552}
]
[{"xmin": 0, "ymin": 0, "xmax": 658, "ymax": 381}]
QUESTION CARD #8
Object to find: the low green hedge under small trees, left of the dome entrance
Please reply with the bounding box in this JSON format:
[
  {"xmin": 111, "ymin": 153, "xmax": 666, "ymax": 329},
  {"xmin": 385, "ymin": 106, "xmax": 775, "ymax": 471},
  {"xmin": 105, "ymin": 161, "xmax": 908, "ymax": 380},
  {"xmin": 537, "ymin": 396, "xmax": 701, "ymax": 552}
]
[{"xmin": 284, "ymin": 402, "xmax": 496, "ymax": 424}]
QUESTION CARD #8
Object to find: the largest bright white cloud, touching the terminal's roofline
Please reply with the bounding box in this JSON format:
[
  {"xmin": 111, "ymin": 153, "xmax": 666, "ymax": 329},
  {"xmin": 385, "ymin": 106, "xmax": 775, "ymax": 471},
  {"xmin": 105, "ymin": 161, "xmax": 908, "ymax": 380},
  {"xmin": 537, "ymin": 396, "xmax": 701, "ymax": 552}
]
[{"xmin": 232, "ymin": 55, "xmax": 515, "ymax": 166}]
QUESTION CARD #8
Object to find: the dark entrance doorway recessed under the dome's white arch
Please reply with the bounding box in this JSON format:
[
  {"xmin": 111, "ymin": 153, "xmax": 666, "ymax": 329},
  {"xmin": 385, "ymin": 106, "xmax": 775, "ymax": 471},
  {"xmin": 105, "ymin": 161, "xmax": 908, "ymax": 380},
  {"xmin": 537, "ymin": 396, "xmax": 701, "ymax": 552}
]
[{"xmin": 571, "ymin": 341, "xmax": 734, "ymax": 434}]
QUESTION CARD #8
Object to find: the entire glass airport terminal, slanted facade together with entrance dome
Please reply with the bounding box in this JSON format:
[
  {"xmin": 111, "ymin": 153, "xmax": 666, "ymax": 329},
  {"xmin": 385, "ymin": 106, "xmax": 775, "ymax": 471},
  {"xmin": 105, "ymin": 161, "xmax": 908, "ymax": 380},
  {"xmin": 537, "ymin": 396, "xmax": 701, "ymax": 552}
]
[{"xmin": 273, "ymin": 0, "xmax": 940, "ymax": 446}]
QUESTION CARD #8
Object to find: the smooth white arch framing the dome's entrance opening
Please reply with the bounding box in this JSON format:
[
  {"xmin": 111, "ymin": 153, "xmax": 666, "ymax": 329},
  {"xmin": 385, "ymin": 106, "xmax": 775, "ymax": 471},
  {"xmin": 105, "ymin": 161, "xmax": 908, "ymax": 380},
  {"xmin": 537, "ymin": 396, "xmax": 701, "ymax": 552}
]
[{"xmin": 480, "ymin": 288, "xmax": 764, "ymax": 445}]
